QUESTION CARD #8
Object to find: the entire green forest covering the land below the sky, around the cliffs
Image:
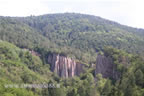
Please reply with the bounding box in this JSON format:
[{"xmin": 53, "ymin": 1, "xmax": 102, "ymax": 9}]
[{"xmin": 0, "ymin": 13, "xmax": 144, "ymax": 96}]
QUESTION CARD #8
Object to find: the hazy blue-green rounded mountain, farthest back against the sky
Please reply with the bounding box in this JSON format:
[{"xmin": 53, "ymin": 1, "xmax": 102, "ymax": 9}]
[{"xmin": 19, "ymin": 13, "xmax": 144, "ymax": 52}]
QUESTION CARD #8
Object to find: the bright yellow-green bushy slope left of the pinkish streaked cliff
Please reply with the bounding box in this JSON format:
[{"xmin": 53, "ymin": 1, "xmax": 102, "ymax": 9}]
[{"xmin": 0, "ymin": 41, "xmax": 51, "ymax": 96}]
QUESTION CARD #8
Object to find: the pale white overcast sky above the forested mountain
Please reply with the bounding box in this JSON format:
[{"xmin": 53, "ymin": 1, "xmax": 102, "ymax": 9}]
[{"xmin": 0, "ymin": 0, "xmax": 144, "ymax": 28}]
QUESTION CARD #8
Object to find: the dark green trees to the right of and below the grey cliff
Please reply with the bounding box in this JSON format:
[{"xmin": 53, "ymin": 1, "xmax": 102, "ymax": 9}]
[{"xmin": 97, "ymin": 47, "xmax": 144, "ymax": 96}]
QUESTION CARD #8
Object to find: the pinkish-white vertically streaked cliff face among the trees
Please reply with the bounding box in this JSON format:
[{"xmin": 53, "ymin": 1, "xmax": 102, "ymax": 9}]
[{"xmin": 48, "ymin": 54, "xmax": 83, "ymax": 78}]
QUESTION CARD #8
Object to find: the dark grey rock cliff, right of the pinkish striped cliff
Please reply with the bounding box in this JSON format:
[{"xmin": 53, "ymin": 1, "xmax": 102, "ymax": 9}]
[{"xmin": 95, "ymin": 55, "xmax": 119, "ymax": 79}]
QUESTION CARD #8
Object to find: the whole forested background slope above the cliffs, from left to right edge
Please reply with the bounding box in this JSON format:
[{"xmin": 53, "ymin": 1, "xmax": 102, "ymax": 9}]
[{"xmin": 0, "ymin": 13, "xmax": 144, "ymax": 63}]
